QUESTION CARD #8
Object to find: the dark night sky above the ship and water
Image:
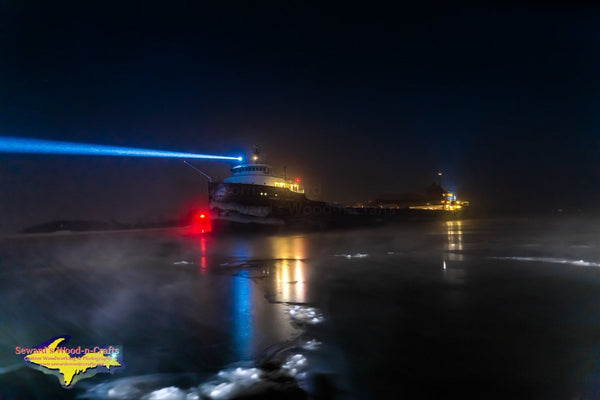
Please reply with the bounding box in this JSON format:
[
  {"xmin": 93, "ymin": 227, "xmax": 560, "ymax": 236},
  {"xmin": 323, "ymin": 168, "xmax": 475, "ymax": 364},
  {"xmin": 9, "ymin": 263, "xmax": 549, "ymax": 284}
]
[{"xmin": 0, "ymin": 1, "xmax": 600, "ymax": 232}]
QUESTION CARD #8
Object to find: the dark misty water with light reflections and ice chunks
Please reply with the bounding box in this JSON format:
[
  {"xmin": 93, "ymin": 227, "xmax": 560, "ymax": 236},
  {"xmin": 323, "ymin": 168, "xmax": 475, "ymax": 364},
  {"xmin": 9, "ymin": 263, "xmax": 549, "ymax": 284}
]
[{"xmin": 0, "ymin": 218, "xmax": 600, "ymax": 400}]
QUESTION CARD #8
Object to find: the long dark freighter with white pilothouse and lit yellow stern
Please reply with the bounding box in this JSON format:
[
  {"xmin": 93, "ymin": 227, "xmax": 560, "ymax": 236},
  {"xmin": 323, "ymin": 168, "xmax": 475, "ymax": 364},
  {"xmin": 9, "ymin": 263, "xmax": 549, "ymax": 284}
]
[{"xmin": 208, "ymin": 152, "xmax": 466, "ymax": 228}]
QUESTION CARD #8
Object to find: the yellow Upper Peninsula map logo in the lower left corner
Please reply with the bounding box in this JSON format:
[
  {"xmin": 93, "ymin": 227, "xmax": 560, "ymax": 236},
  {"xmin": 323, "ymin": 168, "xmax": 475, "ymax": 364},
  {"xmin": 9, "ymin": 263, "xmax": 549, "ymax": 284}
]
[{"xmin": 25, "ymin": 336, "xmax": 122, "ymax": 388}]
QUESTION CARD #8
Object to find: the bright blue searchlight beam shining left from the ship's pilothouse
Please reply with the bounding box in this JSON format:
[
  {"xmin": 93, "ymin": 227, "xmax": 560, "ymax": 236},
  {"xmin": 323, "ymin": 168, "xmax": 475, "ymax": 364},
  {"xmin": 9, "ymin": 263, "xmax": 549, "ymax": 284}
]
[{"xmin": 0, "ymin": 136, "xmax": 243, "ymax": 161}]
